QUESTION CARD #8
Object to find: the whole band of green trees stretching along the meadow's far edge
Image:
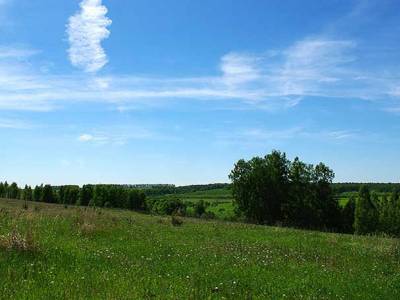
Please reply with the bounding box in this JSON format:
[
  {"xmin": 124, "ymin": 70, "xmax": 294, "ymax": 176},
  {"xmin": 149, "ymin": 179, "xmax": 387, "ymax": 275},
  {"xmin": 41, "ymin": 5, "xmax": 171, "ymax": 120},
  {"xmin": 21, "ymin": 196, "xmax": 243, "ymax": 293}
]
[{"xmin": 0, "ymin": 151, "xmax": 400, "ymax": 236}]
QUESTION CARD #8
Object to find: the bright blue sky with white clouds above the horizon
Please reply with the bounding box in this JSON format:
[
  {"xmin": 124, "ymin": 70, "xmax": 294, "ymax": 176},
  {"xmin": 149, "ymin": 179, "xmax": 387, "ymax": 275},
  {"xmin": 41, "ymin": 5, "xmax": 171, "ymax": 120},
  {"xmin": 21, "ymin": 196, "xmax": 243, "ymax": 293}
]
[{"xmin": 0, "ymin": 0, "xmax": 400, "ymax": 185}]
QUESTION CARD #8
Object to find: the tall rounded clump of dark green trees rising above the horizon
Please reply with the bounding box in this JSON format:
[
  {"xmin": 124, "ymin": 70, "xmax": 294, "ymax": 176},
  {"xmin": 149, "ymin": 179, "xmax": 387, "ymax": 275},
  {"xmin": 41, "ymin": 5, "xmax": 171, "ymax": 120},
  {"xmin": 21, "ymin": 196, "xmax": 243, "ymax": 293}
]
[{"xmin": 230, "ymin": 151, "xmax": 341, "ymax": 229}]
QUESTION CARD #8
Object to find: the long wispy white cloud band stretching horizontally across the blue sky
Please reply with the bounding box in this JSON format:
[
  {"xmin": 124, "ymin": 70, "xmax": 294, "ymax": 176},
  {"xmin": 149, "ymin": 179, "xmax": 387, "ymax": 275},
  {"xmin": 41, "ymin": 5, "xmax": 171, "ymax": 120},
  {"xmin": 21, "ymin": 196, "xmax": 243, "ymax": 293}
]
[{"xmin": 0, "ymin": 37, "xmax": 400, "ymax": 110}]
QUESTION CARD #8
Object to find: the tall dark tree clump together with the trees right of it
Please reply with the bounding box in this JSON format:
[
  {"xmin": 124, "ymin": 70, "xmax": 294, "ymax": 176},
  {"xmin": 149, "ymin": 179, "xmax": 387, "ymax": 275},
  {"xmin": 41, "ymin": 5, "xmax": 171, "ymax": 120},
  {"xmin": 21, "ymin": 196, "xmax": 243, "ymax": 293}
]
[{"xmin": 229, "ymin": 151, "xmax": 400, "ymax": 236}]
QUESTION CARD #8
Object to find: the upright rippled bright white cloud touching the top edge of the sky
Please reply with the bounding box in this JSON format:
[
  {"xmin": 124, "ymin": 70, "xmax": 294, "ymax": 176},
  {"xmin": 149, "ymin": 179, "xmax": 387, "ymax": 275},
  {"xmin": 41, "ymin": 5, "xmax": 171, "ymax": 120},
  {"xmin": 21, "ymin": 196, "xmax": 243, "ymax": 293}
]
[{"xmin": 67, "ymin": 0, "xmax": 112, "ymax": 72}]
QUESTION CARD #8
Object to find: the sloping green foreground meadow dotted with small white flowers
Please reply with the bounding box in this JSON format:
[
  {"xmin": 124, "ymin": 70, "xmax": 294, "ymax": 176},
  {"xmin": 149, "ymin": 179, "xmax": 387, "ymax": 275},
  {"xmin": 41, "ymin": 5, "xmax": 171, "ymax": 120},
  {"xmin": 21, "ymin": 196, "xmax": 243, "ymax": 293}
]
[{"xmin": 0, "ymin": 200, "xmax": 400, "ymax": 299}]
